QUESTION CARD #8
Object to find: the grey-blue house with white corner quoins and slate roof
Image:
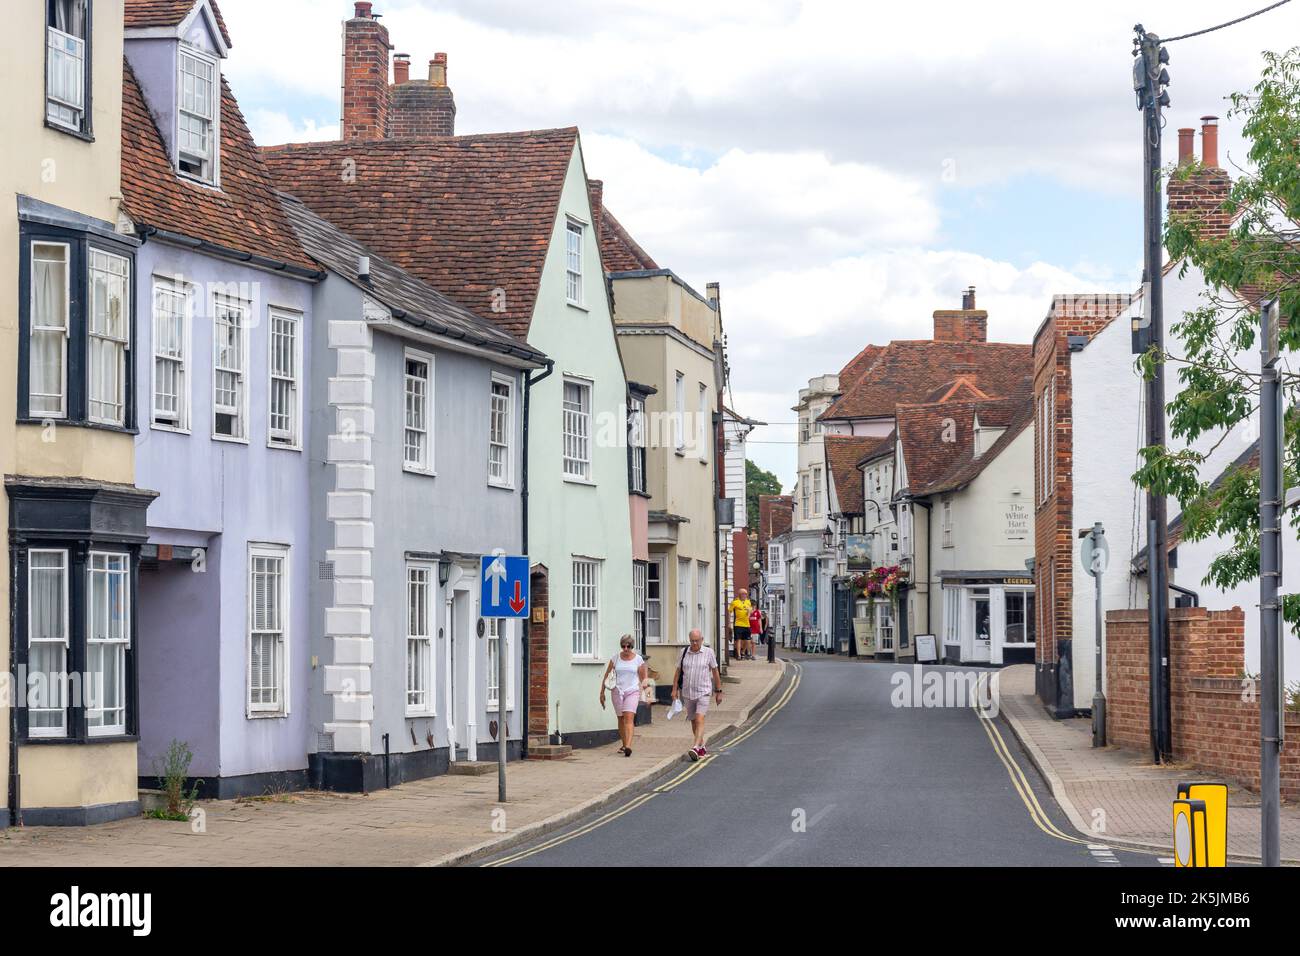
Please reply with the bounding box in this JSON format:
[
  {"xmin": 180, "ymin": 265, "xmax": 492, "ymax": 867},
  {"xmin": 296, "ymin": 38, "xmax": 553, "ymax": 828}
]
[{"xmin": 283, "ymin": 196, "xmax": 547, "ymax": 791}]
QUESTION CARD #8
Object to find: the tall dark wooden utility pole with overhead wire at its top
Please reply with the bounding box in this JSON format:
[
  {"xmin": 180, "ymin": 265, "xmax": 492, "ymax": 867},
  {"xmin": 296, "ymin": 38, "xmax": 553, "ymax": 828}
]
[{"xmin": 1134, "ymin": 23, "xmax": 1173, "ymax": 763}]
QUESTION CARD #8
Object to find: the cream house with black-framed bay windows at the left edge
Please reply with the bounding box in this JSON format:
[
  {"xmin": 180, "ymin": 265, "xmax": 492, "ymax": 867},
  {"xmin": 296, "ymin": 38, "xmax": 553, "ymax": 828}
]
[{"xmin": 0, "ymin": 0, "xmax": 152, "ymax": 825}]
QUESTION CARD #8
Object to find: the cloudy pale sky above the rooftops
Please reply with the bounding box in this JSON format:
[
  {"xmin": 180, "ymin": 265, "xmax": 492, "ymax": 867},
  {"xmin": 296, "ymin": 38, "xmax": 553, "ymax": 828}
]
[{"xmin": 220, "ymin": 0, "xmax": 1300, "ymax": 488}]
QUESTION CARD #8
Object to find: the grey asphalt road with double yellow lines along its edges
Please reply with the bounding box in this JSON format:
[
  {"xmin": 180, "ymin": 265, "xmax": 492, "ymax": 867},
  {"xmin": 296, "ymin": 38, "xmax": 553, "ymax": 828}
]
[{"xmin": 489, "ymin": 658, "xmax": 1158, "ymax": 866}]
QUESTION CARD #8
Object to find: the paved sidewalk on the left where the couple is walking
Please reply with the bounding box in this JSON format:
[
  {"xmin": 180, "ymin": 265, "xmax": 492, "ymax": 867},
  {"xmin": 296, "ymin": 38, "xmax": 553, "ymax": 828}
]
[{"xmin": 0, "ymin": 661, "xmax": 784, "ymax": 866}]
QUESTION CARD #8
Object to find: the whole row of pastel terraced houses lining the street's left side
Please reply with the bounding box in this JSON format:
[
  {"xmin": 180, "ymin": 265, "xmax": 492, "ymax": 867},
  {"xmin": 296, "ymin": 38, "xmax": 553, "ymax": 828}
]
[{"xmin": 0, "ymin": 0, "xmax": 751, "ymax": 825}]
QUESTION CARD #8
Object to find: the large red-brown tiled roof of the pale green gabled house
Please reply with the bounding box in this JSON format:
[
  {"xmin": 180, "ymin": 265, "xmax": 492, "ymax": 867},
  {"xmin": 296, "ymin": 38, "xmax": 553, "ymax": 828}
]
[{"xmin": 261, "ymin": 127, "xmax": 577, "ymax": 339}]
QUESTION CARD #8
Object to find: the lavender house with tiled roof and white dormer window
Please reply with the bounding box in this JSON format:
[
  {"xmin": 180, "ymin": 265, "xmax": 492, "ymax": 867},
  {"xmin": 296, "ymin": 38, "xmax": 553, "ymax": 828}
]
[{"xmin": 122, "ymin": 0, "xmax": 324, "ymax": 797}]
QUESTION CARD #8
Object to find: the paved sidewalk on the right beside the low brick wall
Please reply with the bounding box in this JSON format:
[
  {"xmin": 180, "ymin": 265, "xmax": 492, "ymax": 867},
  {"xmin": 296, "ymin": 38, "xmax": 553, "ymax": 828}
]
[{"xmin": 998, "ymin": 665, "xmax": 1300, "ymax": 862}]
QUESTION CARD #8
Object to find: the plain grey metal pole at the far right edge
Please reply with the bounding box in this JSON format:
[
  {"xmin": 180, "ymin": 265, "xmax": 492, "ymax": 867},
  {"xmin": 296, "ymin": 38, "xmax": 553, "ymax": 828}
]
[{"xmin": 1260, "ymin": 299, "xmax": 1286, "ymax": 866}]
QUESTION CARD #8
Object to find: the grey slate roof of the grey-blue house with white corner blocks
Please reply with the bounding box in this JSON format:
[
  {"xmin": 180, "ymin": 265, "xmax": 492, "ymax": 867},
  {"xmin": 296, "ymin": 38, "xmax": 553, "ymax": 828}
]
[{"xmin": 282, "ymin": 196, "xmax": 546, "ymax": 367}]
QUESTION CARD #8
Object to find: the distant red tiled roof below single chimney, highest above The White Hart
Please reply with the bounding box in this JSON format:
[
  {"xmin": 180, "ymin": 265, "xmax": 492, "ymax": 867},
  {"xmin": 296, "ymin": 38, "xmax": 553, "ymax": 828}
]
[{"xmin": 820, "ymin": 339, "xmax": 1032, "ymax": 421}]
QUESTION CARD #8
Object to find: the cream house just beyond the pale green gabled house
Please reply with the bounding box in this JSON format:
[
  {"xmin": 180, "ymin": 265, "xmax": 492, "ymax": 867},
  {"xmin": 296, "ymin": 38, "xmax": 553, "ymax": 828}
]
[{"xmin": 602, "ymin": 244, "xmax": 722, "ymax": 693}]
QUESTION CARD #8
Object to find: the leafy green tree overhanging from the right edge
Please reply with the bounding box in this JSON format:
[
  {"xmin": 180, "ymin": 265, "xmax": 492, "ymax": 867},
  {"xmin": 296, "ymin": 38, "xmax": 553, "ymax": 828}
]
[{"xmin": 1134, "ymin": 48, "xmax": 1300, "ymax": 624}]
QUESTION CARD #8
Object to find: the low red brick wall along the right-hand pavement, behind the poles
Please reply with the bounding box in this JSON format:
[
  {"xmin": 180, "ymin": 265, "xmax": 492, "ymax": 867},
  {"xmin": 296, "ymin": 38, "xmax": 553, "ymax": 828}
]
[{"xmin": 1106, "ymin": 607, "xmax": 1300, "ymax": 800}]
